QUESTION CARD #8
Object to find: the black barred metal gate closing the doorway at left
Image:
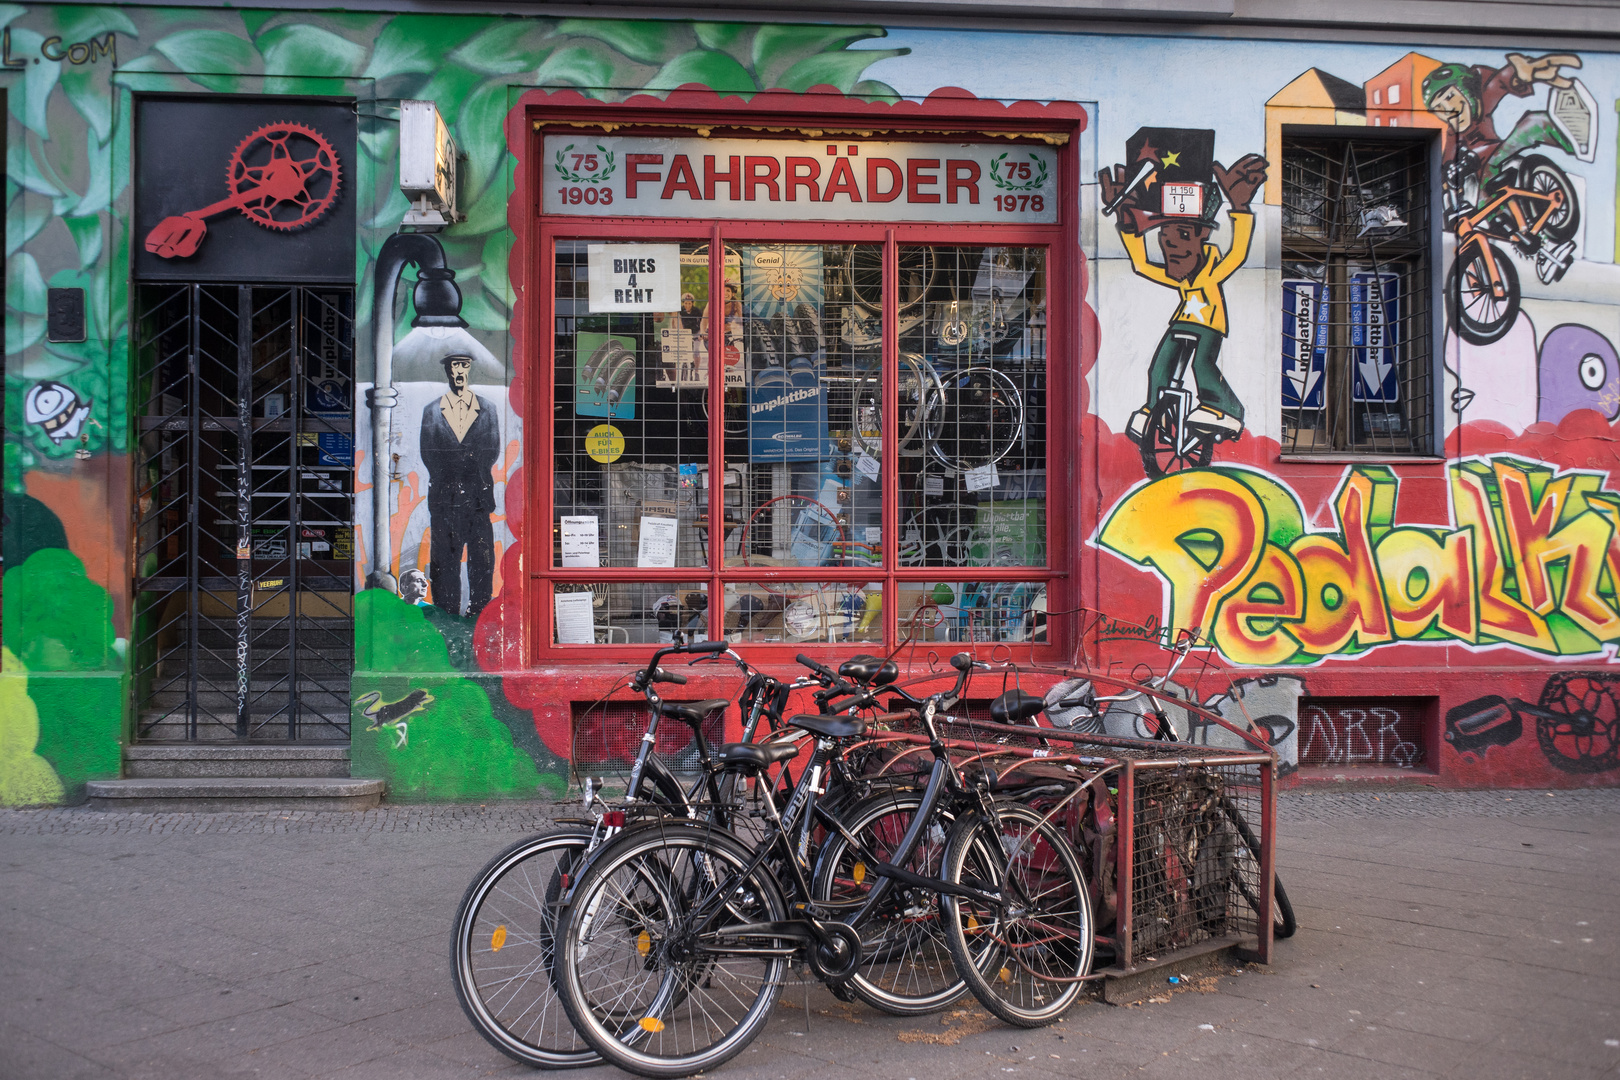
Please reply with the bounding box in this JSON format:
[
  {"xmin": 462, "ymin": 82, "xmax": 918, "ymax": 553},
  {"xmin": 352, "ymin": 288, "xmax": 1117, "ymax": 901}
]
[{"xmin": 130, "ymin": 283, "xmax": 355, "ymax": 742}]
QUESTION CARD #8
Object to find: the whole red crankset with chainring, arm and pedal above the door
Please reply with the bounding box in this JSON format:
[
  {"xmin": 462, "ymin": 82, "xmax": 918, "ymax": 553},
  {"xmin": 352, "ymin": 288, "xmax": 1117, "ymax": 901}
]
[{"xmin": 146, "ymin": 121, "xmax": 342, "ymax": 259}]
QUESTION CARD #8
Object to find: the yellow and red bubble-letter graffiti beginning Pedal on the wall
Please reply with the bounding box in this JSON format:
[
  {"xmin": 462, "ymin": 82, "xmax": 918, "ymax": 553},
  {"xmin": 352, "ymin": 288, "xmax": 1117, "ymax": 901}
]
[{"xmin": 1097, "ymin": 455, "xmax": 1620, "ymax": 665}]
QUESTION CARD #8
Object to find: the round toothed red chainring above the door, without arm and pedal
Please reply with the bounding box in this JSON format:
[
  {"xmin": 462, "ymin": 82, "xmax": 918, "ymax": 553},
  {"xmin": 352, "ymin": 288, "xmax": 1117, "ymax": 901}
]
[{"xmin": 225, "ymin": 123, "xmax": 343, "ymax": 232}]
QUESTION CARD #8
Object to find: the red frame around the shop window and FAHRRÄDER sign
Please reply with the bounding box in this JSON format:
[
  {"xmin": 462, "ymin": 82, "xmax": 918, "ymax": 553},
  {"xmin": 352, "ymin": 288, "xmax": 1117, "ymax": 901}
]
[{"xmin": 512, "ymin": 87, "xmax": 1085, "ymax": 665}]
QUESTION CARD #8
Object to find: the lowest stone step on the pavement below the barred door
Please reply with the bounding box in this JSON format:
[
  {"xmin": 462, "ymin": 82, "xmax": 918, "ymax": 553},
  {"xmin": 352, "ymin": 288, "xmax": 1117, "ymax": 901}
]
[{"xmin": 84, "ymin": 777, "xmax": 387, "ymax": 813}]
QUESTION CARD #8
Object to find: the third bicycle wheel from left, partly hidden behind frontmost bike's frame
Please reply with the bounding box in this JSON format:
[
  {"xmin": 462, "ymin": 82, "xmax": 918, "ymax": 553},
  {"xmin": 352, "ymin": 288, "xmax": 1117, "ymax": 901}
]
[{"xmin": 810, "ymin": 792, "xmax": 967, "ymax": 1017}]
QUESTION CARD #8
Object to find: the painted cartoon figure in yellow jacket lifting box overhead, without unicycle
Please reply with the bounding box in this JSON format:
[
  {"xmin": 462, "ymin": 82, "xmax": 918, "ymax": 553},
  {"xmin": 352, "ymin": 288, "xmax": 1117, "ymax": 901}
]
[{"xmin": 1097, "ymin": 128, "xmax": 1267, "ymax": 444}]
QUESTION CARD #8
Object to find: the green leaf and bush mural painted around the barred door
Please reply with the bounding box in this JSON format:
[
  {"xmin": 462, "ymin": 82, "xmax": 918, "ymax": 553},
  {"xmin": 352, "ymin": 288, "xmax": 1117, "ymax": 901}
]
[{"xmin": 0, "ymin": 5, "xmax": 896, "ymax": 805}]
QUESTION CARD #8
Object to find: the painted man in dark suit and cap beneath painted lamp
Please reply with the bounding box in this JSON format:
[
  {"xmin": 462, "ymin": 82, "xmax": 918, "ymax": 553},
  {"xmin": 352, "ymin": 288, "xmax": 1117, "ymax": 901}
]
[{"xmin": 421, "ymin": 356, "xmax": 501, "ymax": 619}]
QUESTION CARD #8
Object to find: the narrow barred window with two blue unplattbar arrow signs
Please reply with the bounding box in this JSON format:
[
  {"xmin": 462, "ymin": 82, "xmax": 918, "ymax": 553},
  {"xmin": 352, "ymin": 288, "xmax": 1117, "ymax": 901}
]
[{"xmin": 1281, "ymin": 136, "xmax": 1435, "ymax": 453}]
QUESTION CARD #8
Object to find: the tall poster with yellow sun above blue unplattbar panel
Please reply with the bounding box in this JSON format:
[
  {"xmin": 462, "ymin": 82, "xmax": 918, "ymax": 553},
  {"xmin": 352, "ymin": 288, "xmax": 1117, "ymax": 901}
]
[{"xmin": 742, "ymin": 244, "xmax": 831, "ymax": 461}]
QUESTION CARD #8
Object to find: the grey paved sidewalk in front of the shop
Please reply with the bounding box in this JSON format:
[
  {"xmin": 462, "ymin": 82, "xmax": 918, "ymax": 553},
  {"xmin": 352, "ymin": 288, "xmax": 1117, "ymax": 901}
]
[{"xmin": 0, "ymin": 789, "xmax": 1620, "ymax": 1080}]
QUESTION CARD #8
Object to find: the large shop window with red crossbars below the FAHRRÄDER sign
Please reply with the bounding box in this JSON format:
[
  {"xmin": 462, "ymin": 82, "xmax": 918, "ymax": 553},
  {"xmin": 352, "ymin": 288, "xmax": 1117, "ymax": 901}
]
[{"xmin": 536, "ymin": 238, "xmax": 1061, "ymax": 649}]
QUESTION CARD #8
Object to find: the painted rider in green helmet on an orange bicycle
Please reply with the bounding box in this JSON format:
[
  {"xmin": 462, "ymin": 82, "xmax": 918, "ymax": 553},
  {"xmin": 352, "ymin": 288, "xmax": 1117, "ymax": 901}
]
[{"xmin": 1422, "ymin": 52, "xmax": 1597, "ymax": 293}]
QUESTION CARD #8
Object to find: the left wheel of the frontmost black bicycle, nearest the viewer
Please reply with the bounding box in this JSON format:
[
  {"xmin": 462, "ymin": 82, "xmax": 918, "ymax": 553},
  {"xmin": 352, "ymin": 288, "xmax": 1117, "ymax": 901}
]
[{"xmin": 554, "ymin": 823, "xmax": 787, "ymax": 1078}]
